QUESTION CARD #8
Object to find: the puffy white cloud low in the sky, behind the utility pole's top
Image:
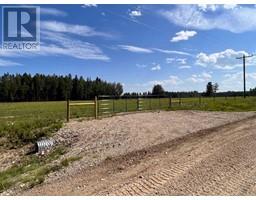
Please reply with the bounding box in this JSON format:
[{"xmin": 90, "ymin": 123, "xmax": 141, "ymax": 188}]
[{"xmin": 195, "ymin": 49, "xmax": 253, "ymax": 70}]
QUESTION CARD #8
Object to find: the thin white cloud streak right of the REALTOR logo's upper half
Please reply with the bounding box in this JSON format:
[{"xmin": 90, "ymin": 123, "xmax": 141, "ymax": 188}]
[{"xmin": 41, "ymin": 21, "xmax": 111, "ymax": 37}]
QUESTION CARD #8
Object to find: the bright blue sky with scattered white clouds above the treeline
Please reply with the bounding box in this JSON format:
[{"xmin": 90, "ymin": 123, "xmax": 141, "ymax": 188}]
[{"xmin": 0, "ymin": 4, "xmax": 256, "ymax": 92}]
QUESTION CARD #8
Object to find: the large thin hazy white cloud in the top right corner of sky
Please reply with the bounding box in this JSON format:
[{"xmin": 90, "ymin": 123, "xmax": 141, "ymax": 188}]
[{"xmin": 160, "ymin": 5, "xmax": 256, "ymax": 33}]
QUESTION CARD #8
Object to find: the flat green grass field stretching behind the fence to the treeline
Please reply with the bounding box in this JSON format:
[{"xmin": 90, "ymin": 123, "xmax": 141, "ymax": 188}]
[{"xmin": 0, "ymin": 97, "xmax": 256, "ymax": 148}]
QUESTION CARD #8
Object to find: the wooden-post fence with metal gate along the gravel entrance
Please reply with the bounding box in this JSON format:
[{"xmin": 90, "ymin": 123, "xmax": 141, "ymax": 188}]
[{"xmin": 66, "ymin": 95, "xmax": 243, "ymax": 121}]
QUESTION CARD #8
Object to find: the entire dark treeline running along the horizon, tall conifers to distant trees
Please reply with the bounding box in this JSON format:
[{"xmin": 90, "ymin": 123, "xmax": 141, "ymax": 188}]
[{"xmin": 0, "ymin": 73, "xmax": 256, "ymax": 102}]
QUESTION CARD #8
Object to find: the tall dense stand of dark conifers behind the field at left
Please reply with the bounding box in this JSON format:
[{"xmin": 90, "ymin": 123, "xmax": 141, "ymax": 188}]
[{"xmin": 0, "ymin": 73, "xmax": 123, "ymax": 102}]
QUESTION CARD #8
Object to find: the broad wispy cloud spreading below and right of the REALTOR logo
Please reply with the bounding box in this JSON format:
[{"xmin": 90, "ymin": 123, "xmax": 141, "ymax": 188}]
[{"xmin": 0, "ymin": 21, "xmax": 110, "ymax": 61}]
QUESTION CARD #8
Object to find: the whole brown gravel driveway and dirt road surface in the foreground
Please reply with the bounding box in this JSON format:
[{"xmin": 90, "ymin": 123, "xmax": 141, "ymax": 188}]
[{"xmin": 20, "ymin": 111, "xmax": 256, "ymax": 195}]
